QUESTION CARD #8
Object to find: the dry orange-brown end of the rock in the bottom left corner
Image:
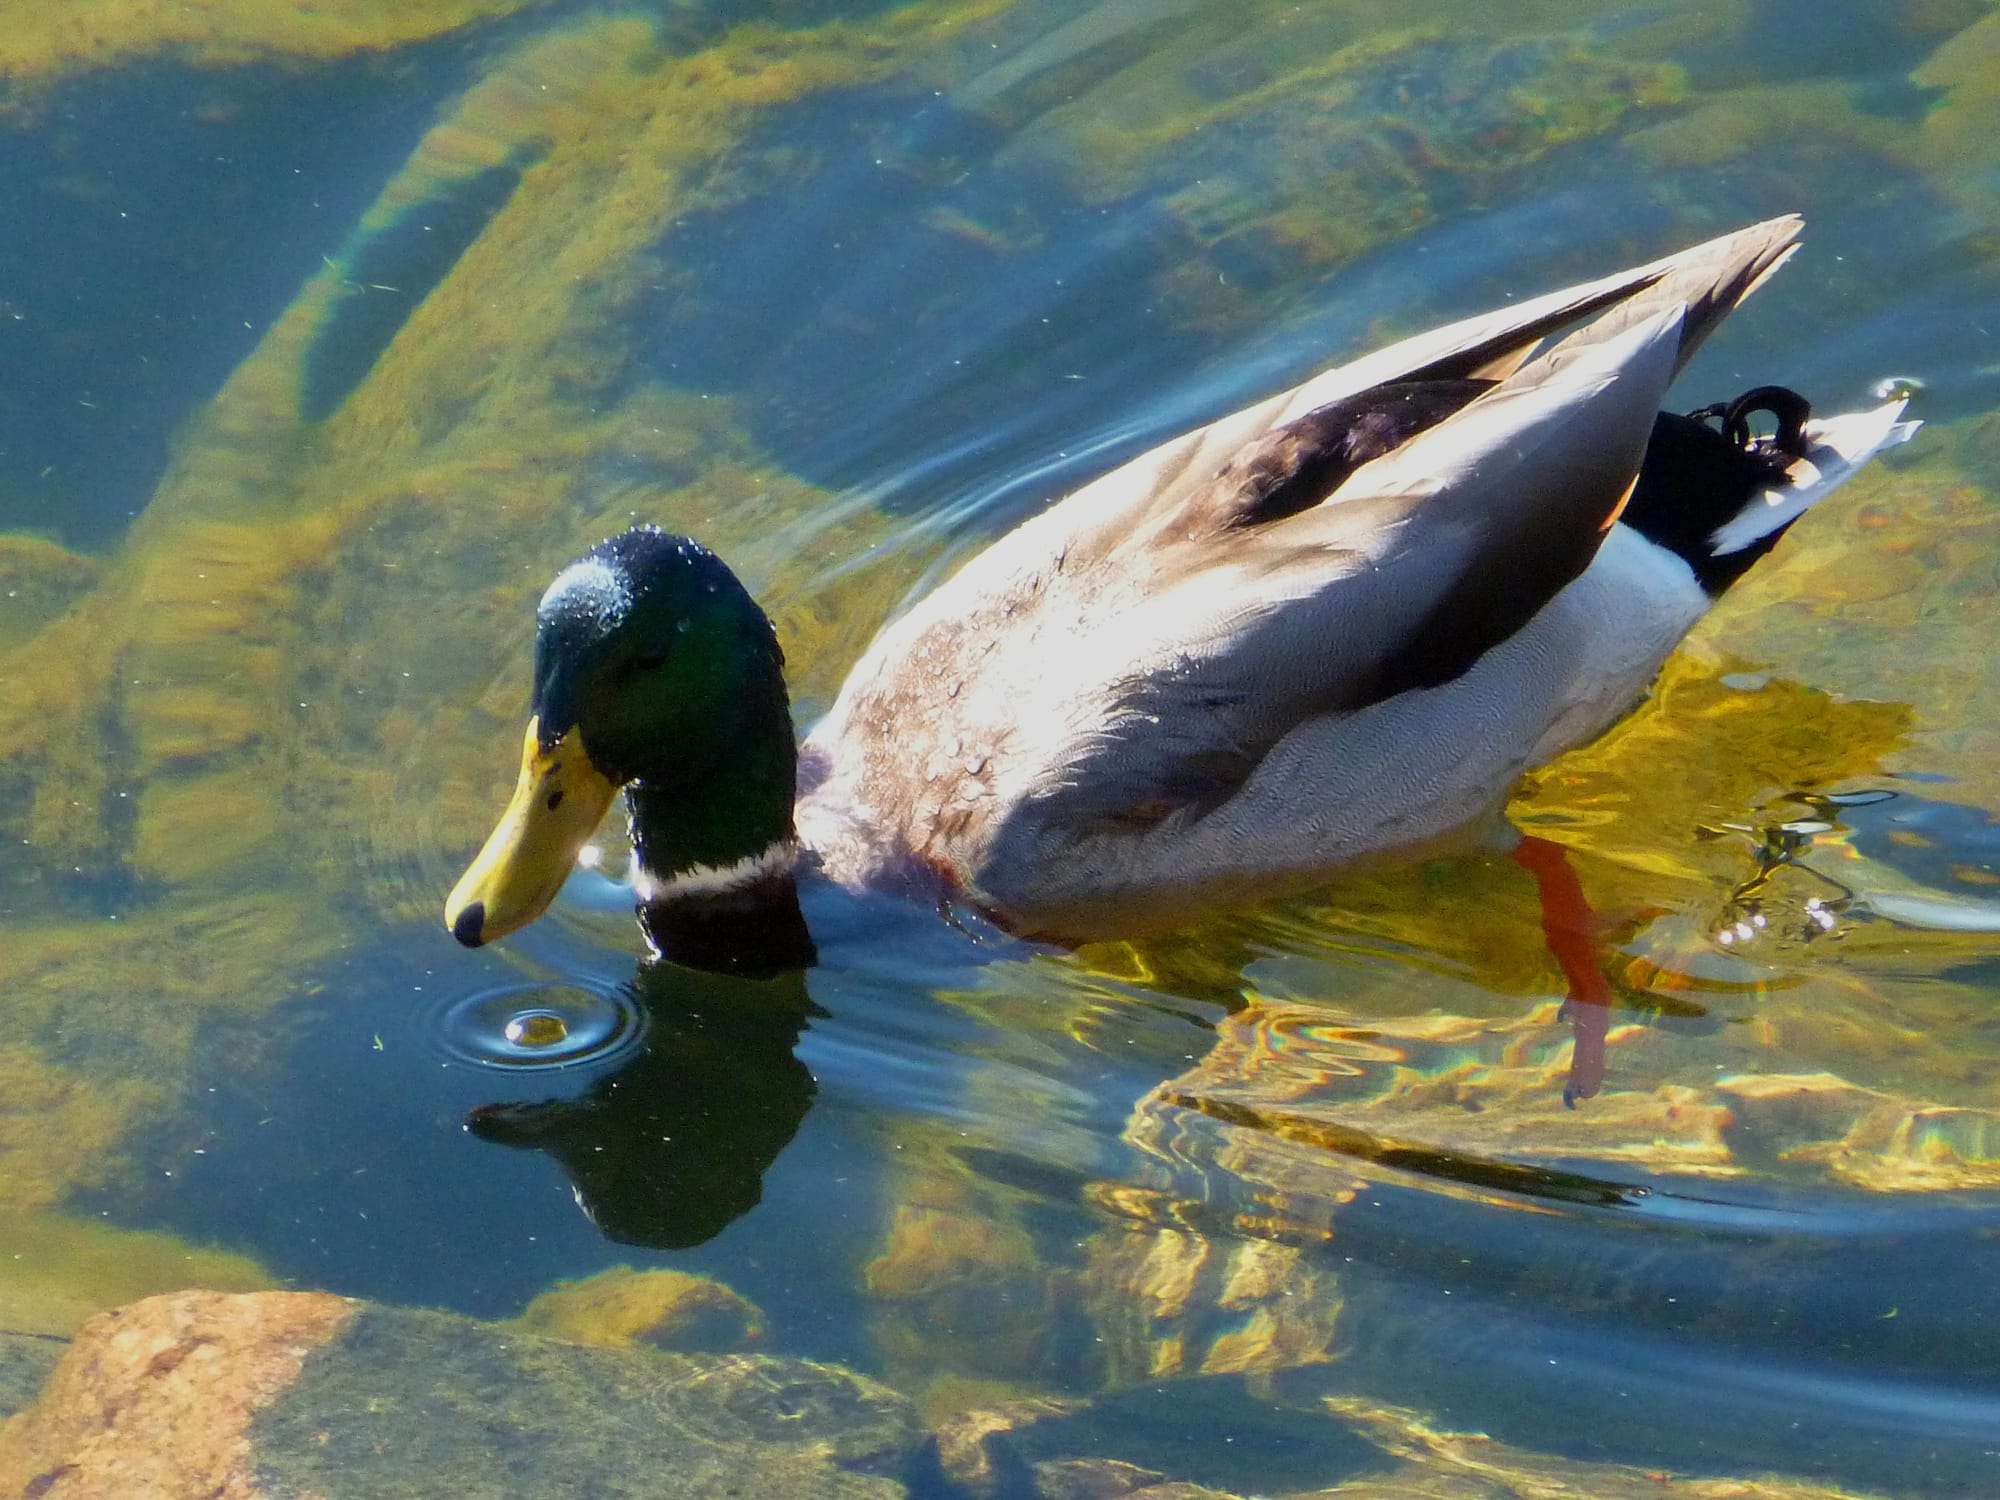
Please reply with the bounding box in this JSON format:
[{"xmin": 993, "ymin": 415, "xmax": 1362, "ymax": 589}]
[{"xmin": 0, "ymin": 1292, "xmax": 358, "ymax": 1500}]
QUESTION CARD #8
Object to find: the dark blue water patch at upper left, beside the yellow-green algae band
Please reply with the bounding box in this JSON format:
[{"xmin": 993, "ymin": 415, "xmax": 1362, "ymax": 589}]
[{"xmin": 0, "ymin": 28, "xmax": 544, "ymax": 548}]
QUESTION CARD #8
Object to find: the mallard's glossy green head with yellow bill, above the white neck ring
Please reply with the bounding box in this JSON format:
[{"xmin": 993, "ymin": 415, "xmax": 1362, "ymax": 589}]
[{"xmin": 444, "ymin": 528, "xmax": 796, "ymax": 948}]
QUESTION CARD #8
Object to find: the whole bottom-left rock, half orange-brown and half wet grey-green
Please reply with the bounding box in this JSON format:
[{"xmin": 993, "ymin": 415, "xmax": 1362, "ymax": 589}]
[{"xmin": 0, "ymin": 1292, "xmax": 920, "ymax": 1500}]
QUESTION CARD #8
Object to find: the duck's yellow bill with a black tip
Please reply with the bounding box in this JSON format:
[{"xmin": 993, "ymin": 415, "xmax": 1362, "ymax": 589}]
[{"xmin": 444, "ymin": 720, "xmax": 618, "ymax": 948}]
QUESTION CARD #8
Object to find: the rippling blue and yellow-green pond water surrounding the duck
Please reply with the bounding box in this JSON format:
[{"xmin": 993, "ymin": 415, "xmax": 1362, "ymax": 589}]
[{"xmin": 0, "ymin": 0, "xmax": 2000, "ymax": 1496}]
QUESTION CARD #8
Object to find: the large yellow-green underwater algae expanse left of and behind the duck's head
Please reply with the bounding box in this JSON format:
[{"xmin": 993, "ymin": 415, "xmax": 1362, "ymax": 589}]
[{"xmin": 0, "ymin": 4, "xmax": 1016, "ymax": 1204}]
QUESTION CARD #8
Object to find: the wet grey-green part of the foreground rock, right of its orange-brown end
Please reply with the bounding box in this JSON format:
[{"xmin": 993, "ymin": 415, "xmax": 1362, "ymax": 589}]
[{"xmin": 250, "ymin": 1306, "xmax": 922, "ymax": 1500}]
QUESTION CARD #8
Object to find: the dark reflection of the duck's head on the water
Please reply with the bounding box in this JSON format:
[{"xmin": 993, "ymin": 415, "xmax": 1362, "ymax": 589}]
[{"xmin": 466, "ymin": 962, "xmax": 826, "ymax": 1250}]
